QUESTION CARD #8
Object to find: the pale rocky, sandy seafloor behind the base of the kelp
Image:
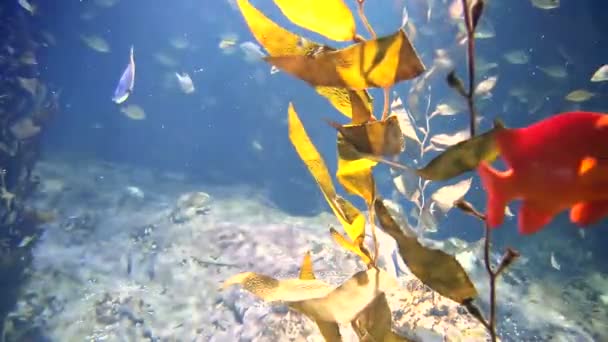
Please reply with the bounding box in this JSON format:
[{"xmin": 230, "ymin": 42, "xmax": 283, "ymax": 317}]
[{"xmin": 3, "ymin": 160, "xmax": 608, "ymax": 341}]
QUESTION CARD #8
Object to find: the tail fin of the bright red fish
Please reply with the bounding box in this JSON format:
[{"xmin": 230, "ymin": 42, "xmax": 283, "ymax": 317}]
[{"xmin": 477, "ymin": 162, "xmax": 513, "ymax": 228}]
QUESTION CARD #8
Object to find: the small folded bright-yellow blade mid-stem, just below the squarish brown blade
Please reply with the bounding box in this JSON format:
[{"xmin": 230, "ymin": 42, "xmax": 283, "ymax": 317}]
[{"xmin": 336, "ymin": 133, "xmax": 378, "ymax": 206}]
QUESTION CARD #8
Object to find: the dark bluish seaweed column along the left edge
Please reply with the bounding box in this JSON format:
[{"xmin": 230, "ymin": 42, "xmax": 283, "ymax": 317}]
[{"xmin": 0, "ymin": 3, "xmax": 58, "ymax": 334}]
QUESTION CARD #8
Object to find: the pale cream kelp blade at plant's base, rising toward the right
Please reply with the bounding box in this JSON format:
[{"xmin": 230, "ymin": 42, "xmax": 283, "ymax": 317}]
[{"xmin": 290, "ymin": 268, "xmax": 398, "ymax": 324}]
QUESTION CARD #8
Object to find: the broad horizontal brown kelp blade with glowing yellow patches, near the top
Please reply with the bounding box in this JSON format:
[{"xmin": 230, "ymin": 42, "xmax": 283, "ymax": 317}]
[{"xmin": 264, "ymin": 30, "xmax": 425, "ymax": 90}]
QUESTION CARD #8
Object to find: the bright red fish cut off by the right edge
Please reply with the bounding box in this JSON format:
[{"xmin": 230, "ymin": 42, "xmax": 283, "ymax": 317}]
[{"xmin": 477, "ymin": 112, "xmax": 608, "ymax": 234}]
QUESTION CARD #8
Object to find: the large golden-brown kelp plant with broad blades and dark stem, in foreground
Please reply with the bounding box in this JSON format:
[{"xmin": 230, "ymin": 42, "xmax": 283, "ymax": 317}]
[{"xmin": 223, "ymin": 0, "xmax": 517, "ymax": 341}]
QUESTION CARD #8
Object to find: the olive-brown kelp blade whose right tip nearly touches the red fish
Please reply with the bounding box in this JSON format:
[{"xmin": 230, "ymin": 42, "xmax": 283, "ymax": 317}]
[{"xmin": 416, "ymin": 122, "xmax": 505, "ymax": 181}]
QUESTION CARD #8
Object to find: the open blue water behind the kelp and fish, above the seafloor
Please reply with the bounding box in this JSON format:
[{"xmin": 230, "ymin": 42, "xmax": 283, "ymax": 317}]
[{"xmin": 4, "ymin": 0, "xmax": 608, "ymax": 340}]
